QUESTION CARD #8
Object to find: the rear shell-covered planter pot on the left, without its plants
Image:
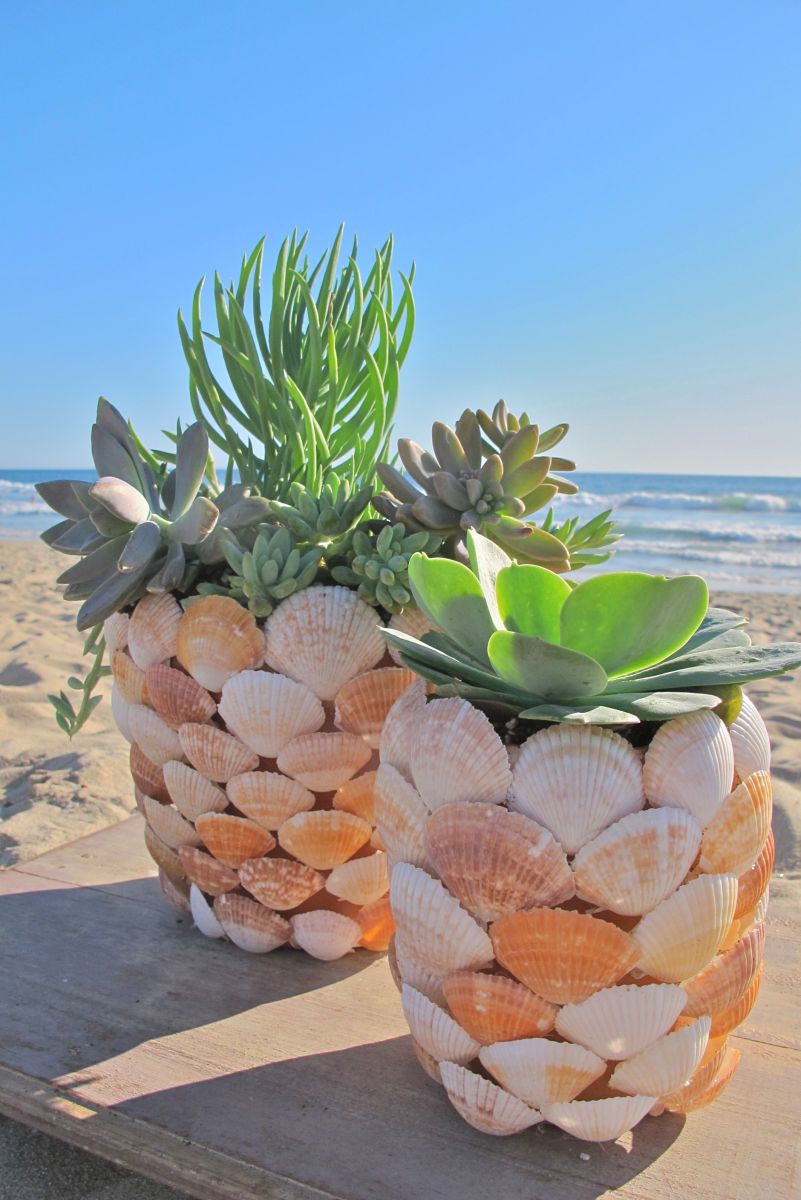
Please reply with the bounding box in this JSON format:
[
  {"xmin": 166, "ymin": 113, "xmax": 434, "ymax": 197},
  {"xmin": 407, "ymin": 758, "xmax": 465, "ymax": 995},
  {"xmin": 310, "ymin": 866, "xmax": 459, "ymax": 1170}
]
[{"xmin": 106, "ymin": 586, "xmax": 415, "ymax": 960}]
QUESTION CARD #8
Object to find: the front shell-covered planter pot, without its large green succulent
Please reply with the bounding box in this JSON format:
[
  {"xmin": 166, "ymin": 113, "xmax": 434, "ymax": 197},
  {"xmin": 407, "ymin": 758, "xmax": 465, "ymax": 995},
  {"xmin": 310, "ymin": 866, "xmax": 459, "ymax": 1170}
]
[{"xmin": 375, "ymin": 682, "xmax": 773, "ymax": 1141}]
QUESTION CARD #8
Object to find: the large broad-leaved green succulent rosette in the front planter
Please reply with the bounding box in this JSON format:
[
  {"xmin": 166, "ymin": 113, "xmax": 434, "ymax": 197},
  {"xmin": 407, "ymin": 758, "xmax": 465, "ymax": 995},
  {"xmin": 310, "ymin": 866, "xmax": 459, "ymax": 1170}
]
[{"xmin": 384, "ymin": 532, "xmax": 801, "ymax": 725}]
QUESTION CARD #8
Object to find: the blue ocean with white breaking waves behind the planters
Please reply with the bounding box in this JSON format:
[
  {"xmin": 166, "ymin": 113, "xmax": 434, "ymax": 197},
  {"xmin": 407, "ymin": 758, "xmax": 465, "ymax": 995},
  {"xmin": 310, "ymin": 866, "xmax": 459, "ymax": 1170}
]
[{"xmin": 0, "ymin": 468, "xmax": 801, "ymax": 594}]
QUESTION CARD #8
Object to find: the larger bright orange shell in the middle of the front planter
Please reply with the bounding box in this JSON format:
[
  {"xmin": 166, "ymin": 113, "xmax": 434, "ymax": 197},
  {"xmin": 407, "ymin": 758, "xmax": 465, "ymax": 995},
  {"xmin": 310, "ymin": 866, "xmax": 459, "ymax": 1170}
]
[{"xmin": 490, "ymin": 908, "xmax": 639, "ymax": 1004}]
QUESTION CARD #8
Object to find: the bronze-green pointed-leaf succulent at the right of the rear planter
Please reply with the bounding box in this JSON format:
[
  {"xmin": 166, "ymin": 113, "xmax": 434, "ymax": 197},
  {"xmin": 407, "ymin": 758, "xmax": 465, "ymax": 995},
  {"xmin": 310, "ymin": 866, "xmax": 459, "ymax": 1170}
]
[{"xmin": 373, "ymin": 401, "xmax": 616, "ymax": 572}]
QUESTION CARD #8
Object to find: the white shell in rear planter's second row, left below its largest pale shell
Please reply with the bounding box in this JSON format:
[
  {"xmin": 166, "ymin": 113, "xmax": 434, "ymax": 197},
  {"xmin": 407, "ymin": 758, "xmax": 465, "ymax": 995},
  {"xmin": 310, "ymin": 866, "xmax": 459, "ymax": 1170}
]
[{"xmin": 219, "ymin": 671, "xmax": 325, "ymax": 758}]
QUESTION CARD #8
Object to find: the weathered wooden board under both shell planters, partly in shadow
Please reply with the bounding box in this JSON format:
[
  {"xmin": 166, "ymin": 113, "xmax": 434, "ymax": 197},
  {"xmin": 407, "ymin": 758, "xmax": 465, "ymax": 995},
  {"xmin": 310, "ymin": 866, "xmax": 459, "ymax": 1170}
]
[{"xmin": 0, "ymin": 818, "xmax": 801, "ymax": 1200}]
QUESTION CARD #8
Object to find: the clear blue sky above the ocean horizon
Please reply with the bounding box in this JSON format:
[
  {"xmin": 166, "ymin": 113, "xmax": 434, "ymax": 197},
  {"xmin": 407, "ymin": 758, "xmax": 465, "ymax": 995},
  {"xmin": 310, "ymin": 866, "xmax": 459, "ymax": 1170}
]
[{"xmin": 0, "ymin": 0, "xmax": 801, "ymax": 475}]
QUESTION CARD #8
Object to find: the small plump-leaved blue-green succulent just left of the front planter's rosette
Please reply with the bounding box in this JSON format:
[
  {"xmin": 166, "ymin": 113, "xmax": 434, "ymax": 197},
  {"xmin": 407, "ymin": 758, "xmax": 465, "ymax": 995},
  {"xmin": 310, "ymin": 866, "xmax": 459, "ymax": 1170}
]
[{"xmin": 331, "ymin": 521, "xmax": 441, "ymax": 612}]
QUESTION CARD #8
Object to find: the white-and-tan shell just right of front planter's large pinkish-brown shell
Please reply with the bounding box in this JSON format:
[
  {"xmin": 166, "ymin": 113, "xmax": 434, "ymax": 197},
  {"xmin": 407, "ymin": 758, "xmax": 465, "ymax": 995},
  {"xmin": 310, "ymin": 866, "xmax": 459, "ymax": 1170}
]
[{"xmin": 573, "ymin": 809, "xmax": 701, "ymax": 916}]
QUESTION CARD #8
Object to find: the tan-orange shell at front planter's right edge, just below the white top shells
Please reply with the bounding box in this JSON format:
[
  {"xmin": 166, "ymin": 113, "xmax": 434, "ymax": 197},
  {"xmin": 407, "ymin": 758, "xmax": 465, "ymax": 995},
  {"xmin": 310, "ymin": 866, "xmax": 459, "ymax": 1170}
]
[{"xmin": 695, "ymin": 772, "xmax": 773, "ymax": 876}]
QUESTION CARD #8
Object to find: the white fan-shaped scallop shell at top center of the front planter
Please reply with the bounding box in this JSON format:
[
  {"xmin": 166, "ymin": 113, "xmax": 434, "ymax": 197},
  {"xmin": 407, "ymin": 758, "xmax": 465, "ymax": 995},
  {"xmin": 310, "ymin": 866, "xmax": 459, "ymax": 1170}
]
[{"xmin": 510, "ymin": 725, "xmax": 644, "ymax": 854}]
